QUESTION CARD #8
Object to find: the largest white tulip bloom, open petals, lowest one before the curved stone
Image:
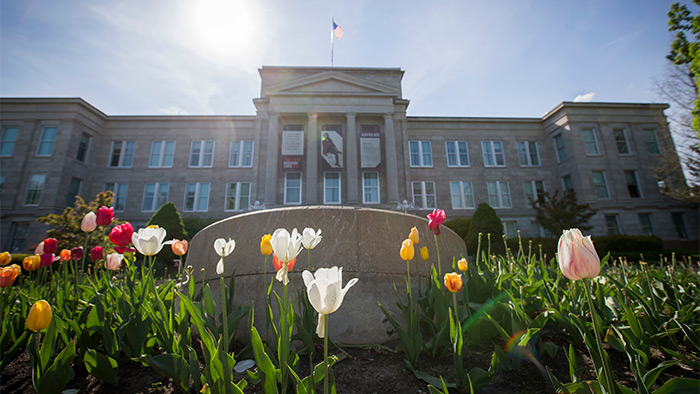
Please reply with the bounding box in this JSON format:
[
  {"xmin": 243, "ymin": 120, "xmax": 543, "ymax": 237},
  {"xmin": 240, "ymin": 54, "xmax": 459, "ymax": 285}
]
[{"xmin": 302, "ymin": 267, "xmax": 357, "ymax": 338}]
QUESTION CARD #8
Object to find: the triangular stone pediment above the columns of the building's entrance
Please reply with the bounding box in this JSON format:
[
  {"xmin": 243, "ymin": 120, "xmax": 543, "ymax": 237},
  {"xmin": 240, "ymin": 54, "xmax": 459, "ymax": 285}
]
[{"xmin": 264, "ymin": 71, "xmax": 400, "ymax": 96}]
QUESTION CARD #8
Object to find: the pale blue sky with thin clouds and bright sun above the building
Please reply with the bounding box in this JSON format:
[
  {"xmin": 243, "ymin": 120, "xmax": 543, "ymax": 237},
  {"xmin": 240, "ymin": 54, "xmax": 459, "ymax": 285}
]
[{"xmin": 0, "ymin": 0, "xmax": 688, "ymax": 117}]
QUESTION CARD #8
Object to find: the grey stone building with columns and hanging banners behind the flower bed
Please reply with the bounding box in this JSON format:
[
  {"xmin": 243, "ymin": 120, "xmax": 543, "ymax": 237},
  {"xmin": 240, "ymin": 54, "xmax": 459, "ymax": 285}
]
[{"xmin": 0, "ymin": 66, "xmax": 698, "ymax": 251}]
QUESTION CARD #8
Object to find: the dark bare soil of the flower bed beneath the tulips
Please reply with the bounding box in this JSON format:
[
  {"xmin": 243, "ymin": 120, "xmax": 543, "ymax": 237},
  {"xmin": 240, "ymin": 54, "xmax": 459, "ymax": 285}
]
[{"xmin": 0, "ymin": 333, "xmax": 700, "ymax": 394}]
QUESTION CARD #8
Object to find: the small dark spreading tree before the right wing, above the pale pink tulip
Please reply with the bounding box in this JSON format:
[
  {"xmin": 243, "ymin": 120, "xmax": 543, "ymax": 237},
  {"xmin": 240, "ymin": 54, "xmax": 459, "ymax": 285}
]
[{"xmin": 532, "ymin": 190, "xmax": 596, "ymax": 236}]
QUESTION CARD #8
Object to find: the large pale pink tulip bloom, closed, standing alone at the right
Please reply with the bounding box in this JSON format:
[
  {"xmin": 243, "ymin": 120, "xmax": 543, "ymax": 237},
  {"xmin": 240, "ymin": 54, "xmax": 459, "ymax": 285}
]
[{"xmin": 559, "ymin": 228, "xmax": 600, "ymax": 280}]
